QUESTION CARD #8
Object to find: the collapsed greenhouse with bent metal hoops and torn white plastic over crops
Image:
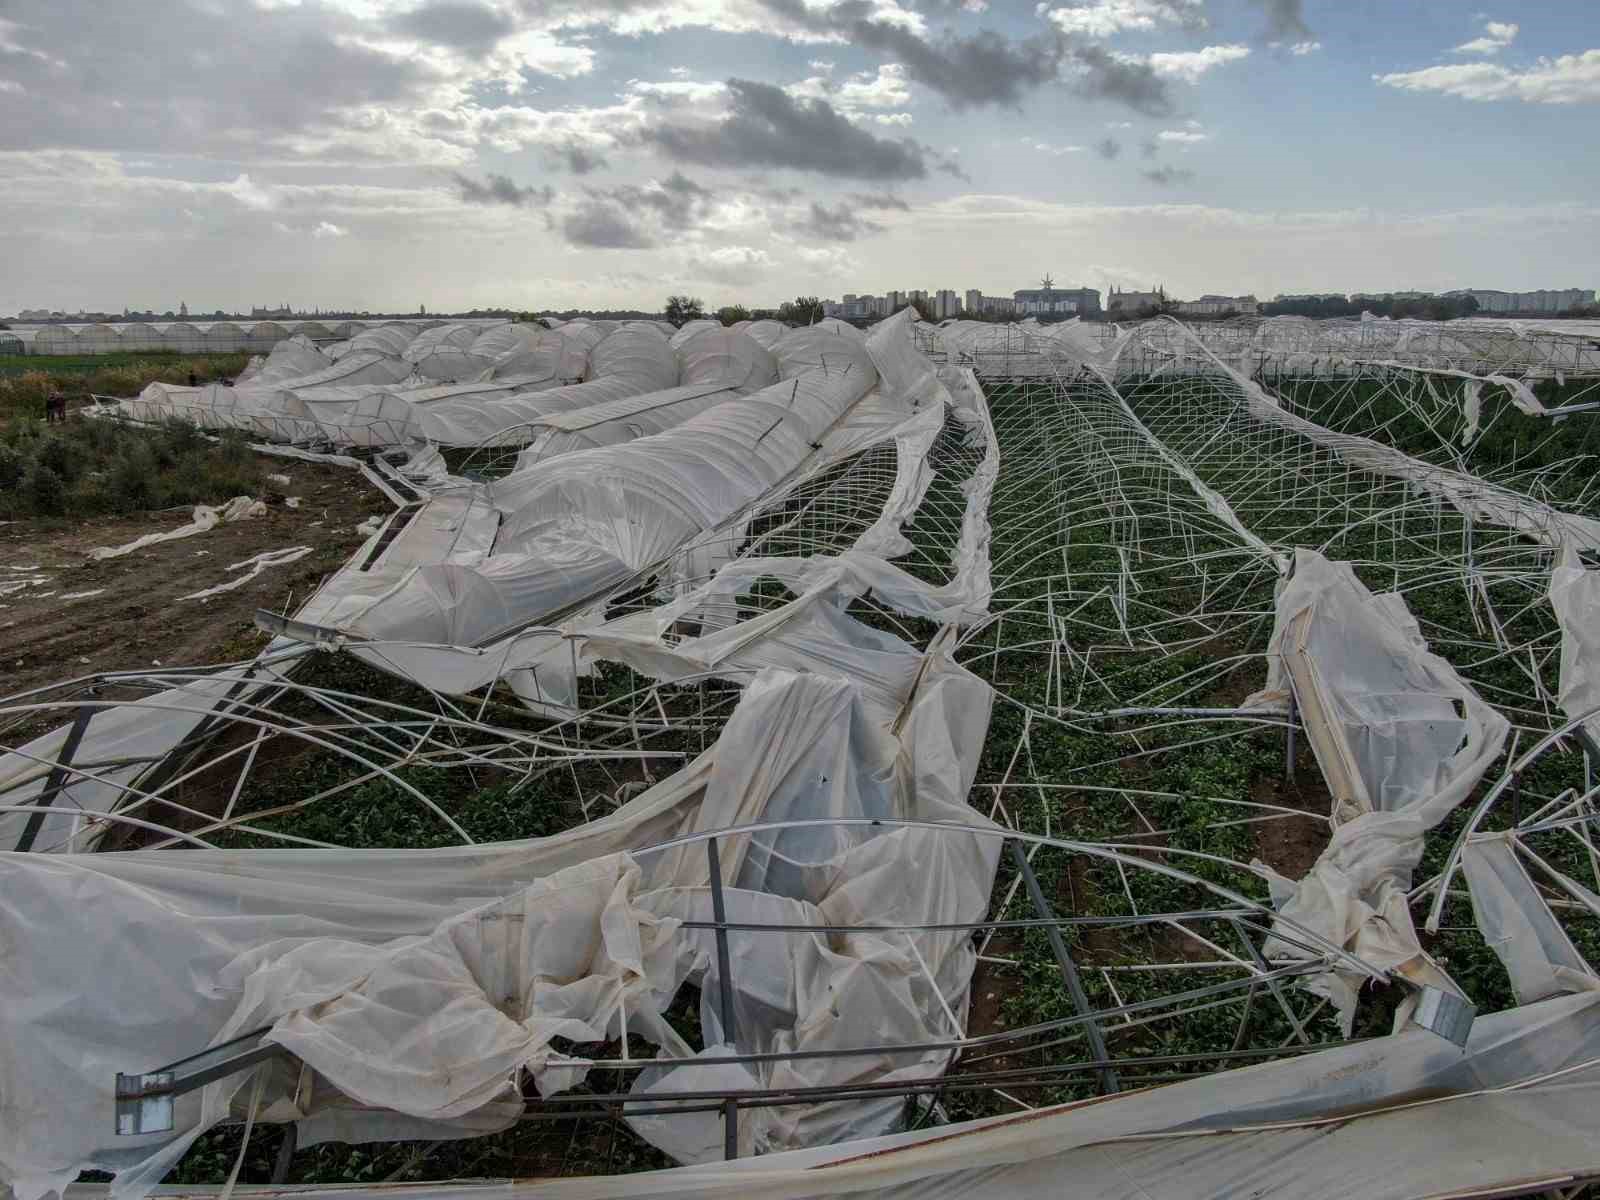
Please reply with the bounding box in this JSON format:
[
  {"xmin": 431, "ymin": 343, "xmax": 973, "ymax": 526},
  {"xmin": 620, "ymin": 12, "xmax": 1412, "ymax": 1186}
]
[{"xmin": 9, "ymin": 310, "xmax": 1600, "ymax": 1200}]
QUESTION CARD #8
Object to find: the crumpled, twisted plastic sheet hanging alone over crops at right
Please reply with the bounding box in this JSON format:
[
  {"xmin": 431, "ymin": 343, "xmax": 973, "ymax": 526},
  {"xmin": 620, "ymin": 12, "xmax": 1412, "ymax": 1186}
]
[{"xmin": 1256, "ymin": 549, "xmax": 1510, "ymax": 1035}]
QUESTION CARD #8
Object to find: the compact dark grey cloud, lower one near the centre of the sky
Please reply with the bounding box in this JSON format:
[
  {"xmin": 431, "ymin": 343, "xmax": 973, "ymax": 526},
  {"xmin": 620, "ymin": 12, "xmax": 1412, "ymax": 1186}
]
[{"xmin": 640, "ymin": 78, "xmax": 938, "ymax": 181}]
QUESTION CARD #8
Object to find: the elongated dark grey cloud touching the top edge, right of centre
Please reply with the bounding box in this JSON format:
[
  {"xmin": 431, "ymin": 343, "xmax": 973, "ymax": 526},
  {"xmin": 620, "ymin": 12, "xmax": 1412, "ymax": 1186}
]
[{"xmin": 762, "ymin": 0, "xmax": 1173, "ymax": 115}]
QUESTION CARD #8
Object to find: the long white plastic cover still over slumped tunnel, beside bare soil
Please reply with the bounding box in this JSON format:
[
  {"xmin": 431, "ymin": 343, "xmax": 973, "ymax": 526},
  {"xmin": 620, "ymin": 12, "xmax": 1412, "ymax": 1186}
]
[{"xmin": 312, "ymin": 320, "xmax": 904, "ymax": 645}]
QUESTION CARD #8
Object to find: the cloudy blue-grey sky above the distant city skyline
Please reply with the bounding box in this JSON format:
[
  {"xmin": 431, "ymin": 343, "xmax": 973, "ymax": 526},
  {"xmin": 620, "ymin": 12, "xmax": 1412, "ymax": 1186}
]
[{"xmin": 0, "ymin": 0, "xmax": 1600, "ymax": 314}]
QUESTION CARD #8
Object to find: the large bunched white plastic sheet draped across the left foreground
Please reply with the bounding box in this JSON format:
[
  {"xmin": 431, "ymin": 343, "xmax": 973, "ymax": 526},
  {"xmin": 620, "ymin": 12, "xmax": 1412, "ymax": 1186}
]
[{"xmin": 0, "ymin": 646, "xmax": 998, "ymax": 1200}]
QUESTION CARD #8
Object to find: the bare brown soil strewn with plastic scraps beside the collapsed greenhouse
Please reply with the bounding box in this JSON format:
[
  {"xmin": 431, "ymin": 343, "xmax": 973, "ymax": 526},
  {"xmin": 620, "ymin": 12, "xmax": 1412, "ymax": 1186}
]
[{"xmin": 0, "ymin": 458, "xmax": 392, "ymax": 720}]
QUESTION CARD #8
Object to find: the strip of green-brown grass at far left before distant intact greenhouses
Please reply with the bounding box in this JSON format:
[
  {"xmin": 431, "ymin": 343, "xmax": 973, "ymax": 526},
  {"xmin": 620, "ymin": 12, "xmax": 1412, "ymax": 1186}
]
[{"xmin": 0, "ymin": 350, "xmax": 250, "ymax": 426}]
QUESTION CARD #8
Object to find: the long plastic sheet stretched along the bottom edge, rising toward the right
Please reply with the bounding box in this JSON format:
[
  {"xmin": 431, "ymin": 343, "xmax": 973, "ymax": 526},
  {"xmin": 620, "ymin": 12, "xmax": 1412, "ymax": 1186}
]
[{"xmin": 40, "ymin": 995, "xmax": 1600, "ymax": 1200}]
